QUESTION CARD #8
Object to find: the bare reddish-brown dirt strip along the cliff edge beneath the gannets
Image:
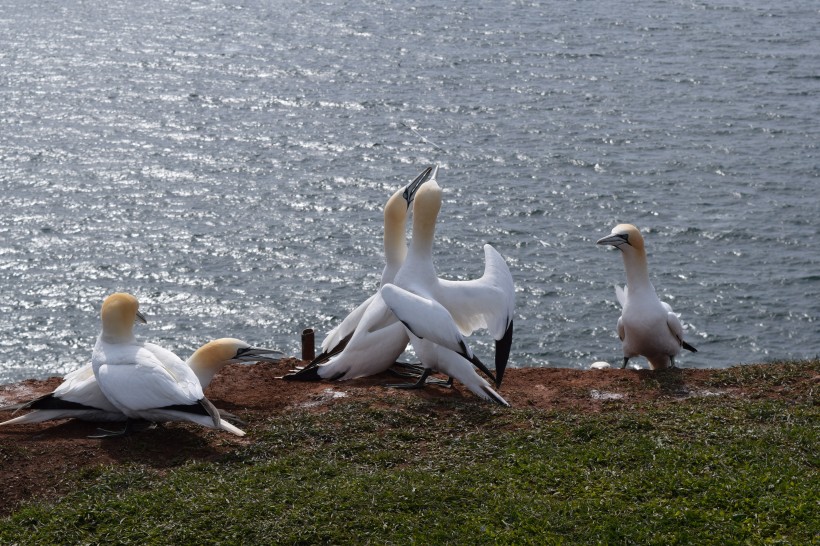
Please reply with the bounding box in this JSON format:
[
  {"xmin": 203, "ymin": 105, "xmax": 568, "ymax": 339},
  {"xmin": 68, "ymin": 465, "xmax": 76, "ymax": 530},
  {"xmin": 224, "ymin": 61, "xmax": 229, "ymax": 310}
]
[{"xmin": 0, "ymin": 359, "xmax": 820, "ymax": 516}]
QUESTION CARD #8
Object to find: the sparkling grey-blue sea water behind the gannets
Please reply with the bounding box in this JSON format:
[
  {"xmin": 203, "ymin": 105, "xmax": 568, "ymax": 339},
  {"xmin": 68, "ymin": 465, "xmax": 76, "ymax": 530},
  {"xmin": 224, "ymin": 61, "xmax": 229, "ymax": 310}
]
[{"xmin": 0, "ymin": 0, "xmax": 820, "ymax": 382}]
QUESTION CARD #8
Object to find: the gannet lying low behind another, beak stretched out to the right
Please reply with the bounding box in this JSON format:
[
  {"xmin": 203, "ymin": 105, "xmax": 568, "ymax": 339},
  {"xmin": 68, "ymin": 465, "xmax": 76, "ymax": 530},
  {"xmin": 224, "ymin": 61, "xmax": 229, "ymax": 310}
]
[{"xmin": 0, "ymin": 338, "xmax": 282, "ymax": 426}]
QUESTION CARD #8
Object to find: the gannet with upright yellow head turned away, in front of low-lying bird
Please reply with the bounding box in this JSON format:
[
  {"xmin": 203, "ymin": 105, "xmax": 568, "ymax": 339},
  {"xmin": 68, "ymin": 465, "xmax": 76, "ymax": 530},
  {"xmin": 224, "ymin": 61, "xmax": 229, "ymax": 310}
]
[{"xmin": 91, "ymin": 293, "xmax": 245, "ymax": 436}]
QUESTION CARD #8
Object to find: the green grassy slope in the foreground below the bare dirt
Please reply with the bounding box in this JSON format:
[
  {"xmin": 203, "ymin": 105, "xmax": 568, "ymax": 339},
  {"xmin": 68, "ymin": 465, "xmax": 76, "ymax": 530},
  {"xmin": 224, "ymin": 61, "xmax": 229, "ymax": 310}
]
[{"xmin": 0, "ymin": 361, "xmax": 820, "ymax": 544}]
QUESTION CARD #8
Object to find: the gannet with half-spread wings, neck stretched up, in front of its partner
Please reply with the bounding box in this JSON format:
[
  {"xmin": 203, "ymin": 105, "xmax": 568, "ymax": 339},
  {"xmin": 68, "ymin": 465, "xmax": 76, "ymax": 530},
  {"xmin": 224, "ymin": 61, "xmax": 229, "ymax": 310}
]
[{"xmin": 381, "ymin": 175, "xmax": 515, "ymax": 405}]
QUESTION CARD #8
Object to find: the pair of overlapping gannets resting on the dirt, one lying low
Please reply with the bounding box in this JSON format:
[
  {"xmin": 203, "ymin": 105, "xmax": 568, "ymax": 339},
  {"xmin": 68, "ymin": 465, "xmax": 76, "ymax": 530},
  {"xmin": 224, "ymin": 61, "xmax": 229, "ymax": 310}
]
[{"xmin": 0, "ymin": 294, "xmax": 282, "ymax": 435}]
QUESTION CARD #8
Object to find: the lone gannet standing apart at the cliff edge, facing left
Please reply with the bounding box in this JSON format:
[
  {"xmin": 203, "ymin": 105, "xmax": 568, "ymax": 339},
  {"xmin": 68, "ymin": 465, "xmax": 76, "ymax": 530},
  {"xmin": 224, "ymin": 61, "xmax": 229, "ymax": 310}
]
[{"xmin": 597, "ymin": 224, "xmax": 697, "ymax": 370}]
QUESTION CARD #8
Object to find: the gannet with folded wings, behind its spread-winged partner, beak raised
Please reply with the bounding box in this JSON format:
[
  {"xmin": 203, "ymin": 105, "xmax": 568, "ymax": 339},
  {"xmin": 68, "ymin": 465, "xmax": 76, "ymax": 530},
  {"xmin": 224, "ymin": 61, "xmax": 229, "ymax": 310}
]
[{"xmin": 285, "ymin": 167, "xmax": 438, "ymax": 381}]
